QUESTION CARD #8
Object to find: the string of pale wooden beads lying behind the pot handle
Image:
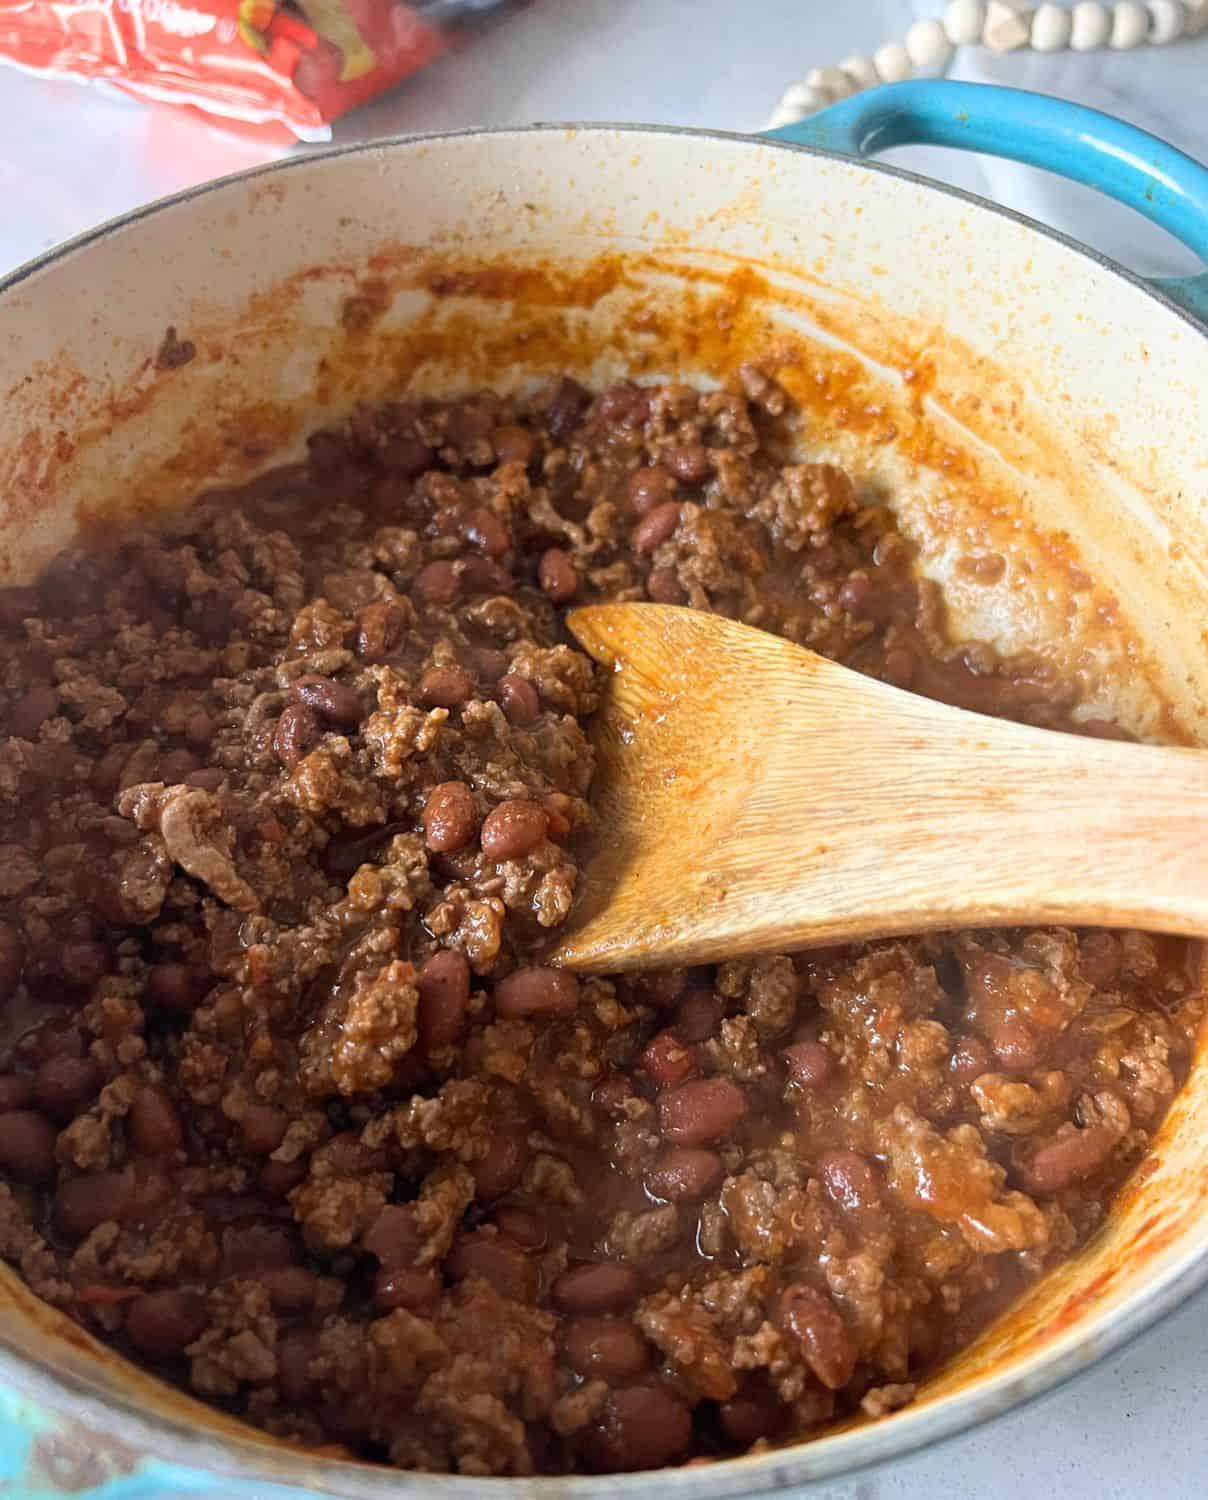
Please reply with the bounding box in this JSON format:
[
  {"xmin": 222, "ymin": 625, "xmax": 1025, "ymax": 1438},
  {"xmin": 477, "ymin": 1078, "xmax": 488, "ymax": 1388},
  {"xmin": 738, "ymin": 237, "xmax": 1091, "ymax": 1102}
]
[{"xmin": 768, "ymin": 0, "xmax": 1208, "ymax": 129}]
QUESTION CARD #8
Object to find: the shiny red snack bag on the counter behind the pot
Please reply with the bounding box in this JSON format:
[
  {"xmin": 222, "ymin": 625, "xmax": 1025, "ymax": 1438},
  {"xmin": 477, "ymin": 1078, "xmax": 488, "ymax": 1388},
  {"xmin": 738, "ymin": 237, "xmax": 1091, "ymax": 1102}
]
[{"xmin": 0, "ymin": 0, "xmax": 441, "ymax": 141}]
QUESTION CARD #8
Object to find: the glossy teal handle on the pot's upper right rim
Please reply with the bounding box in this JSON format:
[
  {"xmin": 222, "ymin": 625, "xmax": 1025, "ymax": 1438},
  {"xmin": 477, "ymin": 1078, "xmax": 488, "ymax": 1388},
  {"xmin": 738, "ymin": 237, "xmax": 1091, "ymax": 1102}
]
[{"xmin": 767, "ymin": 80, "xmax": 1208, "ymax": 323}]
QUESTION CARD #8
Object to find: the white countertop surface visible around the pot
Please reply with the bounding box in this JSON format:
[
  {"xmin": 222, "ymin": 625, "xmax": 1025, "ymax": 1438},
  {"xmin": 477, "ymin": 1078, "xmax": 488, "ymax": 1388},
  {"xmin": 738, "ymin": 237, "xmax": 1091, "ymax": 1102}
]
[{"xmin": 0, "ymin": 0, "xmax": 1208, "ymax": 1500}]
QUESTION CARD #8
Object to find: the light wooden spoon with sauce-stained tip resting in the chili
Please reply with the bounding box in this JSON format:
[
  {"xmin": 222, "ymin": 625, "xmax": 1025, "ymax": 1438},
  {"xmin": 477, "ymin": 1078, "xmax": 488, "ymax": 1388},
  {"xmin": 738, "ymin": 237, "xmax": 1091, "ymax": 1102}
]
[{"xmin": 549, "ymin": 605, "xmax": 1208, "ymax": 972}]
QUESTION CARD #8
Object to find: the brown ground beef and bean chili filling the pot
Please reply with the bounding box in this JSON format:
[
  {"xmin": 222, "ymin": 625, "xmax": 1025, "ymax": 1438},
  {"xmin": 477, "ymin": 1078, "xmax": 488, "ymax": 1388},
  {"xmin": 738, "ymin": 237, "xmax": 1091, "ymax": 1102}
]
[{"xmin": 0, "ymin": 368, "xmax": 1200, "ymax": 1475}]
